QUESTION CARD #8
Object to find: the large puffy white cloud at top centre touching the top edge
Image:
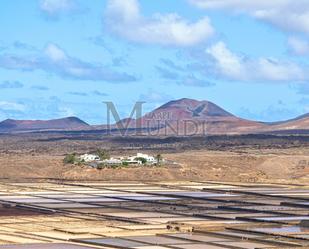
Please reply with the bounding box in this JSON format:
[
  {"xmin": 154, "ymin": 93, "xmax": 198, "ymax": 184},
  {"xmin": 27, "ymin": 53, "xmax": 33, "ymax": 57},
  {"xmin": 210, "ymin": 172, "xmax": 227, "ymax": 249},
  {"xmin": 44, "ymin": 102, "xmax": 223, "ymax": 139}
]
[{"xmin": 105, "ymin": 0, "xmax": 214, "ymax": 46}]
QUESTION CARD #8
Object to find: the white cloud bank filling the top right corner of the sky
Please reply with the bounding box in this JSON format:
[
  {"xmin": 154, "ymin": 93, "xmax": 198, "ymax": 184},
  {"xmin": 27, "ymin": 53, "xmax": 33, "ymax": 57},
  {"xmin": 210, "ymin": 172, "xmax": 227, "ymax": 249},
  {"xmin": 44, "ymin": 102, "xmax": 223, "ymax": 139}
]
[{"xmin": 188, "ymin": 0, "xmax": 309, "ymax": 34}]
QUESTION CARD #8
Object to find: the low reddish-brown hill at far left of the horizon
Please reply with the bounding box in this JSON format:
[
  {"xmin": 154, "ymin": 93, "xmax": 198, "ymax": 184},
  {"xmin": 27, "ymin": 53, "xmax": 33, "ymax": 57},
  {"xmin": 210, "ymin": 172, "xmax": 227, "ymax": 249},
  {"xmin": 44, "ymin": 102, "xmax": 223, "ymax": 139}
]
[{"xmin": 0, "ymin": 117, "xmax": 91, "ymax": 132}]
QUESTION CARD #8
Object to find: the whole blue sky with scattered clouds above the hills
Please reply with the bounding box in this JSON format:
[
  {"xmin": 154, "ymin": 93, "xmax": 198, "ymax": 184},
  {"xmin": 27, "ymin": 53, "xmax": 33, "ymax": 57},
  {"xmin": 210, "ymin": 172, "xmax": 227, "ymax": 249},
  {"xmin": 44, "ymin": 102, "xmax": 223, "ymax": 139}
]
[{"xmin": 0, "ymin": 0, "xmax": 309, "ymax": 124}]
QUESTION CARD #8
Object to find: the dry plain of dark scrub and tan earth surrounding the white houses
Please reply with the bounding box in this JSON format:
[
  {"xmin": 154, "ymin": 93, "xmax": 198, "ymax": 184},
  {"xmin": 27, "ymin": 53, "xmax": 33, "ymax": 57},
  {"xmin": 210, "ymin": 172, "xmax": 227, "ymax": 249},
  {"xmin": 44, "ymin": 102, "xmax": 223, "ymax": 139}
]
[{"xmin": 0, "ymin": 134, "xmax": 309, "ymax": 183}]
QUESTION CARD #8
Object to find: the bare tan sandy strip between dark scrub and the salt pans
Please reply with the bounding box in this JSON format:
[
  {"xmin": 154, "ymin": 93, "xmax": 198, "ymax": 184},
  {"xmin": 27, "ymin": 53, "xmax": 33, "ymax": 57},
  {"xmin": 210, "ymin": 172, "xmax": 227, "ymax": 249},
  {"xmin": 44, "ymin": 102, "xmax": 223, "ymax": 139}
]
[{"xmin": 0, "ymin": 148, "xmax": 309, "ymax": 183}]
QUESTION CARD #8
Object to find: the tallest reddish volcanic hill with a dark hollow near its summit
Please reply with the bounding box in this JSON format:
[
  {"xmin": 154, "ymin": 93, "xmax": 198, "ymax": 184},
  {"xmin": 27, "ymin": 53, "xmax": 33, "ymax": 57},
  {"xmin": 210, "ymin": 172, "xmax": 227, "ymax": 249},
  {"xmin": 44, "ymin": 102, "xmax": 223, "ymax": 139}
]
[{"xmin": 112, "ymin": 98, "xmax": 265, "ymax": 135}]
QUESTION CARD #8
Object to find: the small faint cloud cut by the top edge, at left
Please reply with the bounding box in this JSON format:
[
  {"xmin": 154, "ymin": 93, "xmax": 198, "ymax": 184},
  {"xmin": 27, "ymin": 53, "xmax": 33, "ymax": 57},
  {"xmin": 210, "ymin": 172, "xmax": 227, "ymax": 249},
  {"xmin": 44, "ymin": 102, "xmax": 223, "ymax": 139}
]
[{"xmin": 39, "ymin": 0, "xmax": 76, "ymax": 16}]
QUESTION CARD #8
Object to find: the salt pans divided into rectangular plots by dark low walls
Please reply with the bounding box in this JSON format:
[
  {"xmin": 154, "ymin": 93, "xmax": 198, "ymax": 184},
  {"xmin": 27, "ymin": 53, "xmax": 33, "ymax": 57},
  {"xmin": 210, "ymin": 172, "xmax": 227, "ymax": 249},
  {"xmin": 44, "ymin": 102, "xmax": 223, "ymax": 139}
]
[{"xmin": 0, "ymin": 180, "xmax": 309, "ymax": 249}]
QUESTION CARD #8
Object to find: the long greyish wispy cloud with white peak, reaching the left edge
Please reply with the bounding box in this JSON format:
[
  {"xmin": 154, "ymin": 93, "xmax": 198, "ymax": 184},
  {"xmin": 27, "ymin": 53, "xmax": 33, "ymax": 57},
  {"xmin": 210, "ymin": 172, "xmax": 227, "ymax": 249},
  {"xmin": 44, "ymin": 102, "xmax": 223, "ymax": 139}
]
[{"xmin": 0, "ymin": 43, "xmax": 136, "ymax": 83}]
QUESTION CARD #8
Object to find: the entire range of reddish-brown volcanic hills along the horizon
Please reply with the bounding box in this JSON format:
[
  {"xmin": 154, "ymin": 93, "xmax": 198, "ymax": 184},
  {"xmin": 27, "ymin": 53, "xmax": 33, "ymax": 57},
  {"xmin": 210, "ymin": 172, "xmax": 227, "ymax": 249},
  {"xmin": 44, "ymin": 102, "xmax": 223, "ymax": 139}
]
[{"xmin": 0, "ymin": 98, "xmax": 309, "ymax": 136}]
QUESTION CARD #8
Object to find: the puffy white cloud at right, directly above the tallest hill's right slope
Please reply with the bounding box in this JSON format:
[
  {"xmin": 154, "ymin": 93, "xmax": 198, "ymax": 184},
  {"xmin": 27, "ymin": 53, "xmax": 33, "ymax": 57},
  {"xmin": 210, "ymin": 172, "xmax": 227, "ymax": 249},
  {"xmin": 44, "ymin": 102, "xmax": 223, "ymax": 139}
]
[{"xmin": 206, "ymin": 42, "xmax": 309, "ymax": 81}]
